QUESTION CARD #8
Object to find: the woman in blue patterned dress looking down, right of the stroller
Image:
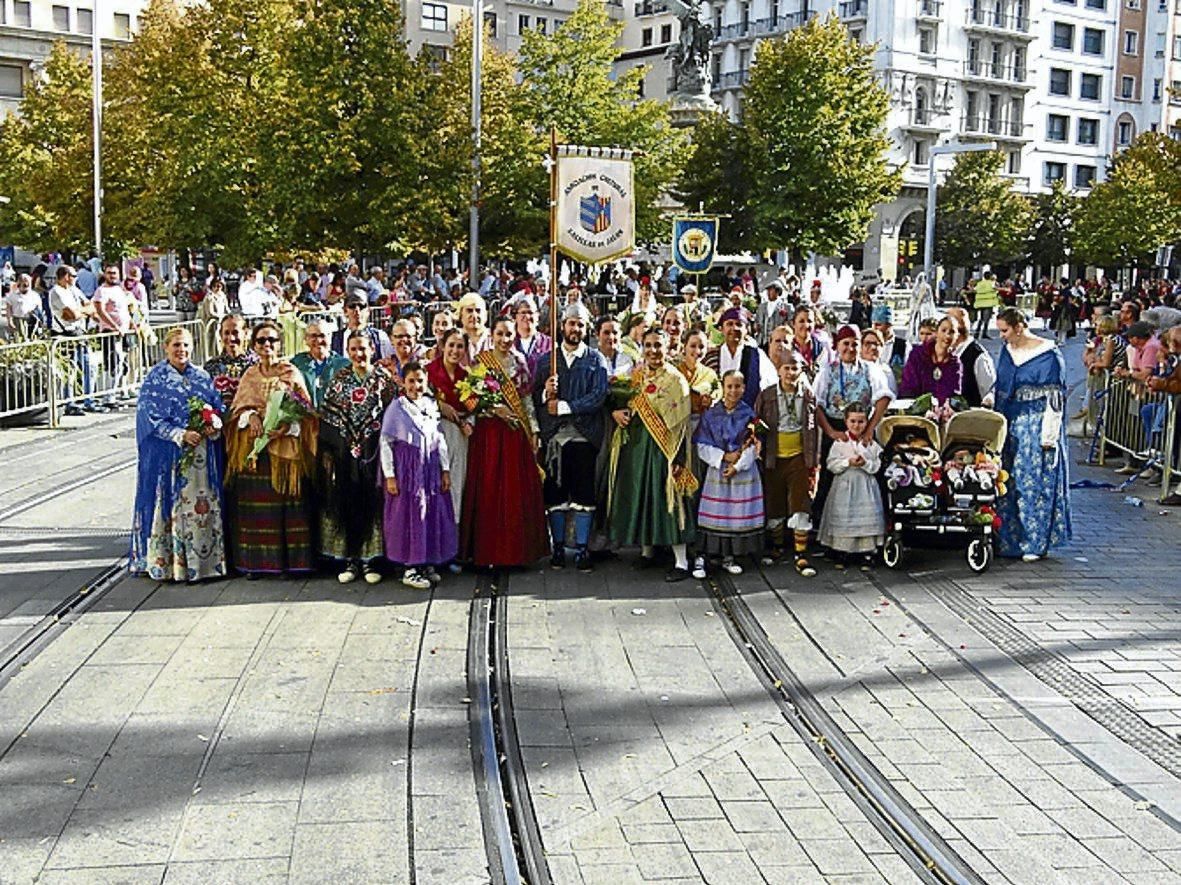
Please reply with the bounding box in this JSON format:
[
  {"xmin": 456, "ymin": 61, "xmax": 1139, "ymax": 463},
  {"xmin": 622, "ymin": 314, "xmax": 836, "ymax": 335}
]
[{"xmin": 996, "ymin": 307, "xmax": 1070, "ymax": 562}]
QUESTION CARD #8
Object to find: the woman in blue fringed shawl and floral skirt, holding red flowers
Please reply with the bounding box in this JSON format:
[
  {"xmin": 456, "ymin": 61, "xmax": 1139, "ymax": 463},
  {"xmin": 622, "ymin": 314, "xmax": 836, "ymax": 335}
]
[{"xmin": 131, "ymin": 328, "xmax": 226, "ymax": 583}]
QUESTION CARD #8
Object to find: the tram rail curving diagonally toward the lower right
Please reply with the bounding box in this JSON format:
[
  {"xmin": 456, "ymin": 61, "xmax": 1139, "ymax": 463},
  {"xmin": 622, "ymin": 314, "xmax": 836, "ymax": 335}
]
[{"xmin": 706, "ymin": 574, "xmax": 984, "ymax": 885}]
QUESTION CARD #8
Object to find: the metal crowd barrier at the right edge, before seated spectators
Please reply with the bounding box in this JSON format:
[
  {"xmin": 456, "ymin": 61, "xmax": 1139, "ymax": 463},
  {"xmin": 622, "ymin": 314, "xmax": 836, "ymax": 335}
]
[{"xmin": 1089, "ymin": 372, "xmax": 1181, "ymax": 497}]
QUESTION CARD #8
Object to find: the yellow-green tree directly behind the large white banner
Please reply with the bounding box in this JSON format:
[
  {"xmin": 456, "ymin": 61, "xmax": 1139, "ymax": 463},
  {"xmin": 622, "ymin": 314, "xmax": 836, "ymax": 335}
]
[{"xmin": 517, "ymin": 0, "xmax": 687, "ymax": 246}]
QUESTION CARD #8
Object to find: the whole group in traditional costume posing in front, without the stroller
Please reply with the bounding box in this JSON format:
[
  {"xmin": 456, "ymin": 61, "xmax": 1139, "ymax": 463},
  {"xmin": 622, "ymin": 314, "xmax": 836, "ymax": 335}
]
[{"xmin": 132, "ymin": 280, "xmax": 1070, "ymax": 590}]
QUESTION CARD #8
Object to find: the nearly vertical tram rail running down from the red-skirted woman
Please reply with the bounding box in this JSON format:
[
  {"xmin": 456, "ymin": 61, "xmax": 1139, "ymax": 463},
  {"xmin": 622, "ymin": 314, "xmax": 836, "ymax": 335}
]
[{"xmin": 468, "ymin": 572, "xmax": 553, "ymax": 885}]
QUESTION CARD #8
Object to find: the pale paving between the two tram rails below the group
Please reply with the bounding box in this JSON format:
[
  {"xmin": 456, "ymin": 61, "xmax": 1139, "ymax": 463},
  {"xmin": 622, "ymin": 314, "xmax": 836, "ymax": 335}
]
[{"xmin": 509, "ymin": 564, "xmax": 915, "ymax": 884}]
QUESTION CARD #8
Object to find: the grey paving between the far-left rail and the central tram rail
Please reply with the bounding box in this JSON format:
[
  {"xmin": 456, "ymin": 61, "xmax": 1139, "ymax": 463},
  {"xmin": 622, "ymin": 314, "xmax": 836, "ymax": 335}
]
[{"xmin": 0, "ymin": 579, "xmax": 487, "ymax": 885}]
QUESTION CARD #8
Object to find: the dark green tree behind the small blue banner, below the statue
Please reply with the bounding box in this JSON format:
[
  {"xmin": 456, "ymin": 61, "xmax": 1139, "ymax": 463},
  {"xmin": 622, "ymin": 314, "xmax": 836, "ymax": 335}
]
[{"xmin": 673, "ymin": 113, "xmax": 758, "ymax": 252}]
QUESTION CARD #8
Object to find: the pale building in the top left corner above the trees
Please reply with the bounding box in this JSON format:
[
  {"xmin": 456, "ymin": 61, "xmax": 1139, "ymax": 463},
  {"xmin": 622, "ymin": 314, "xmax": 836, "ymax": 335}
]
[{"xmin": 0, "ymin": 0, "xmax": 136, "ymax": 116}]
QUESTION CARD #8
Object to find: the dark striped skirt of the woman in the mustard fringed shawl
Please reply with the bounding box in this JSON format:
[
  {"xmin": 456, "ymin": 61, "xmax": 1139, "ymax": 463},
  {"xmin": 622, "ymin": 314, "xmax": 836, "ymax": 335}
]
[{"xmin": 227, "ymin": 453, "xmax": 314, "ymax": 574}]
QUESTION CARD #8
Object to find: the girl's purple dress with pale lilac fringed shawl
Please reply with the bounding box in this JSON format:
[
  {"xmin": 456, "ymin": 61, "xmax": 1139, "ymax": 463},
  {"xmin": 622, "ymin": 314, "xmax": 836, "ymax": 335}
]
[{"xmin": 381, "ymin": 397, "xmax": 457, "ymax": 566}]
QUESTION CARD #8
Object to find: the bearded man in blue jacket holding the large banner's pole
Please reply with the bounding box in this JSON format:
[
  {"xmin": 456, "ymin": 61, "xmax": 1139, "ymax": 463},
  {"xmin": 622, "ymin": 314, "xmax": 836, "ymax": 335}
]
[{"xmin": 533, "ymin": 304, "xmax": 607, "ymax": 572}]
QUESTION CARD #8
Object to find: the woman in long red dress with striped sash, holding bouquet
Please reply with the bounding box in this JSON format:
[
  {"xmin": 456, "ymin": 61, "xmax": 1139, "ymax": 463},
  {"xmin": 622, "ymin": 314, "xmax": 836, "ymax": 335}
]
[{"xmin": 459, "ymin": 319, "xmax": 549, "ymax": 567}]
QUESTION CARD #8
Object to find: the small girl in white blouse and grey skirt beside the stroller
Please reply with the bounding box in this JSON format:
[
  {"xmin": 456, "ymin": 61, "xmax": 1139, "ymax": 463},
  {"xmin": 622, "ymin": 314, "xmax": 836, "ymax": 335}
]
[{"xmin": 818, "ymin": 403, "xmax": 886, "ymax": 571}]
